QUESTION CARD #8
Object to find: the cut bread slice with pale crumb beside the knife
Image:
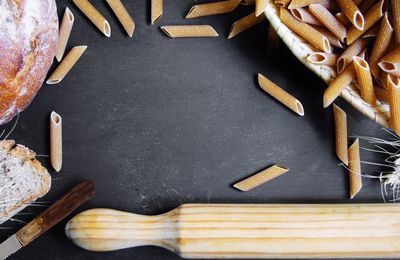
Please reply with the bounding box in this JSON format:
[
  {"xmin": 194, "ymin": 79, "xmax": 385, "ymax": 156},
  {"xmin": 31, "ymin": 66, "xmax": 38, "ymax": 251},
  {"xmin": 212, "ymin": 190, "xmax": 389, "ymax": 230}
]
[{"xmin": 0, "ymin": 140, "xmax": 51, "ymax": 224}]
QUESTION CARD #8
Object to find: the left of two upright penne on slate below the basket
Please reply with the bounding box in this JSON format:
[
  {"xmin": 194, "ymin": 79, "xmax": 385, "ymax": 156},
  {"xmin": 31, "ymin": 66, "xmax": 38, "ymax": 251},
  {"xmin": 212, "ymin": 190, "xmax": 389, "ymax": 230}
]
[{"xmin": 333, "ymin": 104, "xmax": 349, "ymax": 165}]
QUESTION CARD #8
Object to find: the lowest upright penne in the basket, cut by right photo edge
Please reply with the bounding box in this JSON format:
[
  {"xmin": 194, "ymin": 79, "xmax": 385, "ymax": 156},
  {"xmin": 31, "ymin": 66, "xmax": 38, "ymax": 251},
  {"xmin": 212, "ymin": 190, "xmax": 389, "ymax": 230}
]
[{"xmin": 386, "ymin": 75, "xmax": 400, "ymax": 135}]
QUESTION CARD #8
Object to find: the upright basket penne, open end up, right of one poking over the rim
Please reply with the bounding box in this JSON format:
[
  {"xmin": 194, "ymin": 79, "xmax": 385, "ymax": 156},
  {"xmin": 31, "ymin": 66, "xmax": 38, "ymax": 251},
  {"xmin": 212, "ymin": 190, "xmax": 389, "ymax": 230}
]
[{"xmin": 353, "ymin": 56, "xmax": 376, "ymax": 106}]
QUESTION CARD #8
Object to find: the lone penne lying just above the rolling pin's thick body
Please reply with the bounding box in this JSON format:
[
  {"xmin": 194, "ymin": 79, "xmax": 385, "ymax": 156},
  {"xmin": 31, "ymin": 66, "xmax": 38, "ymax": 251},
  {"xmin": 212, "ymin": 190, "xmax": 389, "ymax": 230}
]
[{"xmin": 233, "ymin": 165, "xmax": 289, "ymax": 191}]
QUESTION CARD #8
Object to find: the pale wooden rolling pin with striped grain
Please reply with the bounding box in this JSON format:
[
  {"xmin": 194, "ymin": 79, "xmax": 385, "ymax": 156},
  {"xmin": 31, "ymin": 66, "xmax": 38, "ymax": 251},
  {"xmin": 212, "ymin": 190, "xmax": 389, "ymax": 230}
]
[{"xmin": 66, "ymin": 204, "xmax": 400, "ymax": 258}]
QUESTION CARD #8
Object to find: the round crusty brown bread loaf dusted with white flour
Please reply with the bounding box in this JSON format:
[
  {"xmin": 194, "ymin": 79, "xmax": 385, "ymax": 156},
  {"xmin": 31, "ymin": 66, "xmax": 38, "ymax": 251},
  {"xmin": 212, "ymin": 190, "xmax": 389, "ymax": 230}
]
[{"xmin": 0, "ymin": 0, "xmax": 58, "ymax": 125}]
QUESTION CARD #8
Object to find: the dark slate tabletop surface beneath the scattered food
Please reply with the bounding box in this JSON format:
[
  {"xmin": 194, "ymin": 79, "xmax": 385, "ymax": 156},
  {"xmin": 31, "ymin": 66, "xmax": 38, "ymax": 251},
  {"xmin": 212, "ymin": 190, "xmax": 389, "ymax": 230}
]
[{"xmin": 0, "ymin": 0, "xmax": 394, "ymax": 260}]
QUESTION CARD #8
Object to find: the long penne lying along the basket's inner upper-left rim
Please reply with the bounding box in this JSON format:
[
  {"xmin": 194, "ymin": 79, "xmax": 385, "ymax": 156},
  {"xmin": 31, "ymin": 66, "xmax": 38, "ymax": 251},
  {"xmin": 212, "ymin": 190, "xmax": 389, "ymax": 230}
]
[{"xmin": 280, "ymin": 8, "xmax": 332, "ymax": 52}]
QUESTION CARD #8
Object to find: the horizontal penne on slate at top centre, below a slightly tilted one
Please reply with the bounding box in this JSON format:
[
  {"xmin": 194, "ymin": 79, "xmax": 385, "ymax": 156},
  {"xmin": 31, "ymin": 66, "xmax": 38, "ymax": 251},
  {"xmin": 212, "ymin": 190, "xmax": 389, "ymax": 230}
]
[{"xmin": 161, "ymin": 25, "xmax": 218, "ymax": 38}]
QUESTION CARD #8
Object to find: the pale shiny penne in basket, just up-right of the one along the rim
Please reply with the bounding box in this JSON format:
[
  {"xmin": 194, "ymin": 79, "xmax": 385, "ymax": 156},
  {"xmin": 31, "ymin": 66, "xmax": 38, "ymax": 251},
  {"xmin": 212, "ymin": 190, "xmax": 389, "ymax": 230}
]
[{"xmin": 309, "ymin": 4, "xmax": 347, "ymax": 41}]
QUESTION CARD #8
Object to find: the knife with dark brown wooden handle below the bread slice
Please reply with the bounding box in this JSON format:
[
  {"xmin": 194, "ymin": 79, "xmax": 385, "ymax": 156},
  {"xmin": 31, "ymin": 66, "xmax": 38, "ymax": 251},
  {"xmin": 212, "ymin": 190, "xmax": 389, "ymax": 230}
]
[{"xmin": 0, "ymin": 180, "xmax": 94, "ymax": 260}]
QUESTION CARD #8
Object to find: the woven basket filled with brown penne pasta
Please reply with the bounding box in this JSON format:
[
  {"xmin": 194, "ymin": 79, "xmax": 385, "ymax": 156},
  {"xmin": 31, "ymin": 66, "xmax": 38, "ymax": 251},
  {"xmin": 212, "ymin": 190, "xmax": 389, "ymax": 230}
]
[{"xmin": 264, "ymin": 0, "xmax": 400, "ymax": 134}]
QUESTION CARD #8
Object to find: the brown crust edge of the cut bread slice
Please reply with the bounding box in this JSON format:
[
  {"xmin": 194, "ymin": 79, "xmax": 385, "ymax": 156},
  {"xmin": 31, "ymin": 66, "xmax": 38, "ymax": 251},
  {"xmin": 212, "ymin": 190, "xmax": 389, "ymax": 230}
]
[{"xmin": 0, "ymin": 140, "xmax": 51, "ymax": 224}]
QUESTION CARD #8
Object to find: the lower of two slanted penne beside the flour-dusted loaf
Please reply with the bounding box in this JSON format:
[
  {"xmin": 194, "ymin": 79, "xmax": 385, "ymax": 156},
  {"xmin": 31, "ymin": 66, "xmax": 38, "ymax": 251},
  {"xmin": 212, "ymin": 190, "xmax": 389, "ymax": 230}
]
[{"xmin": 46, "ymin": 46, "xmax": 87, "ymax": 84}]
